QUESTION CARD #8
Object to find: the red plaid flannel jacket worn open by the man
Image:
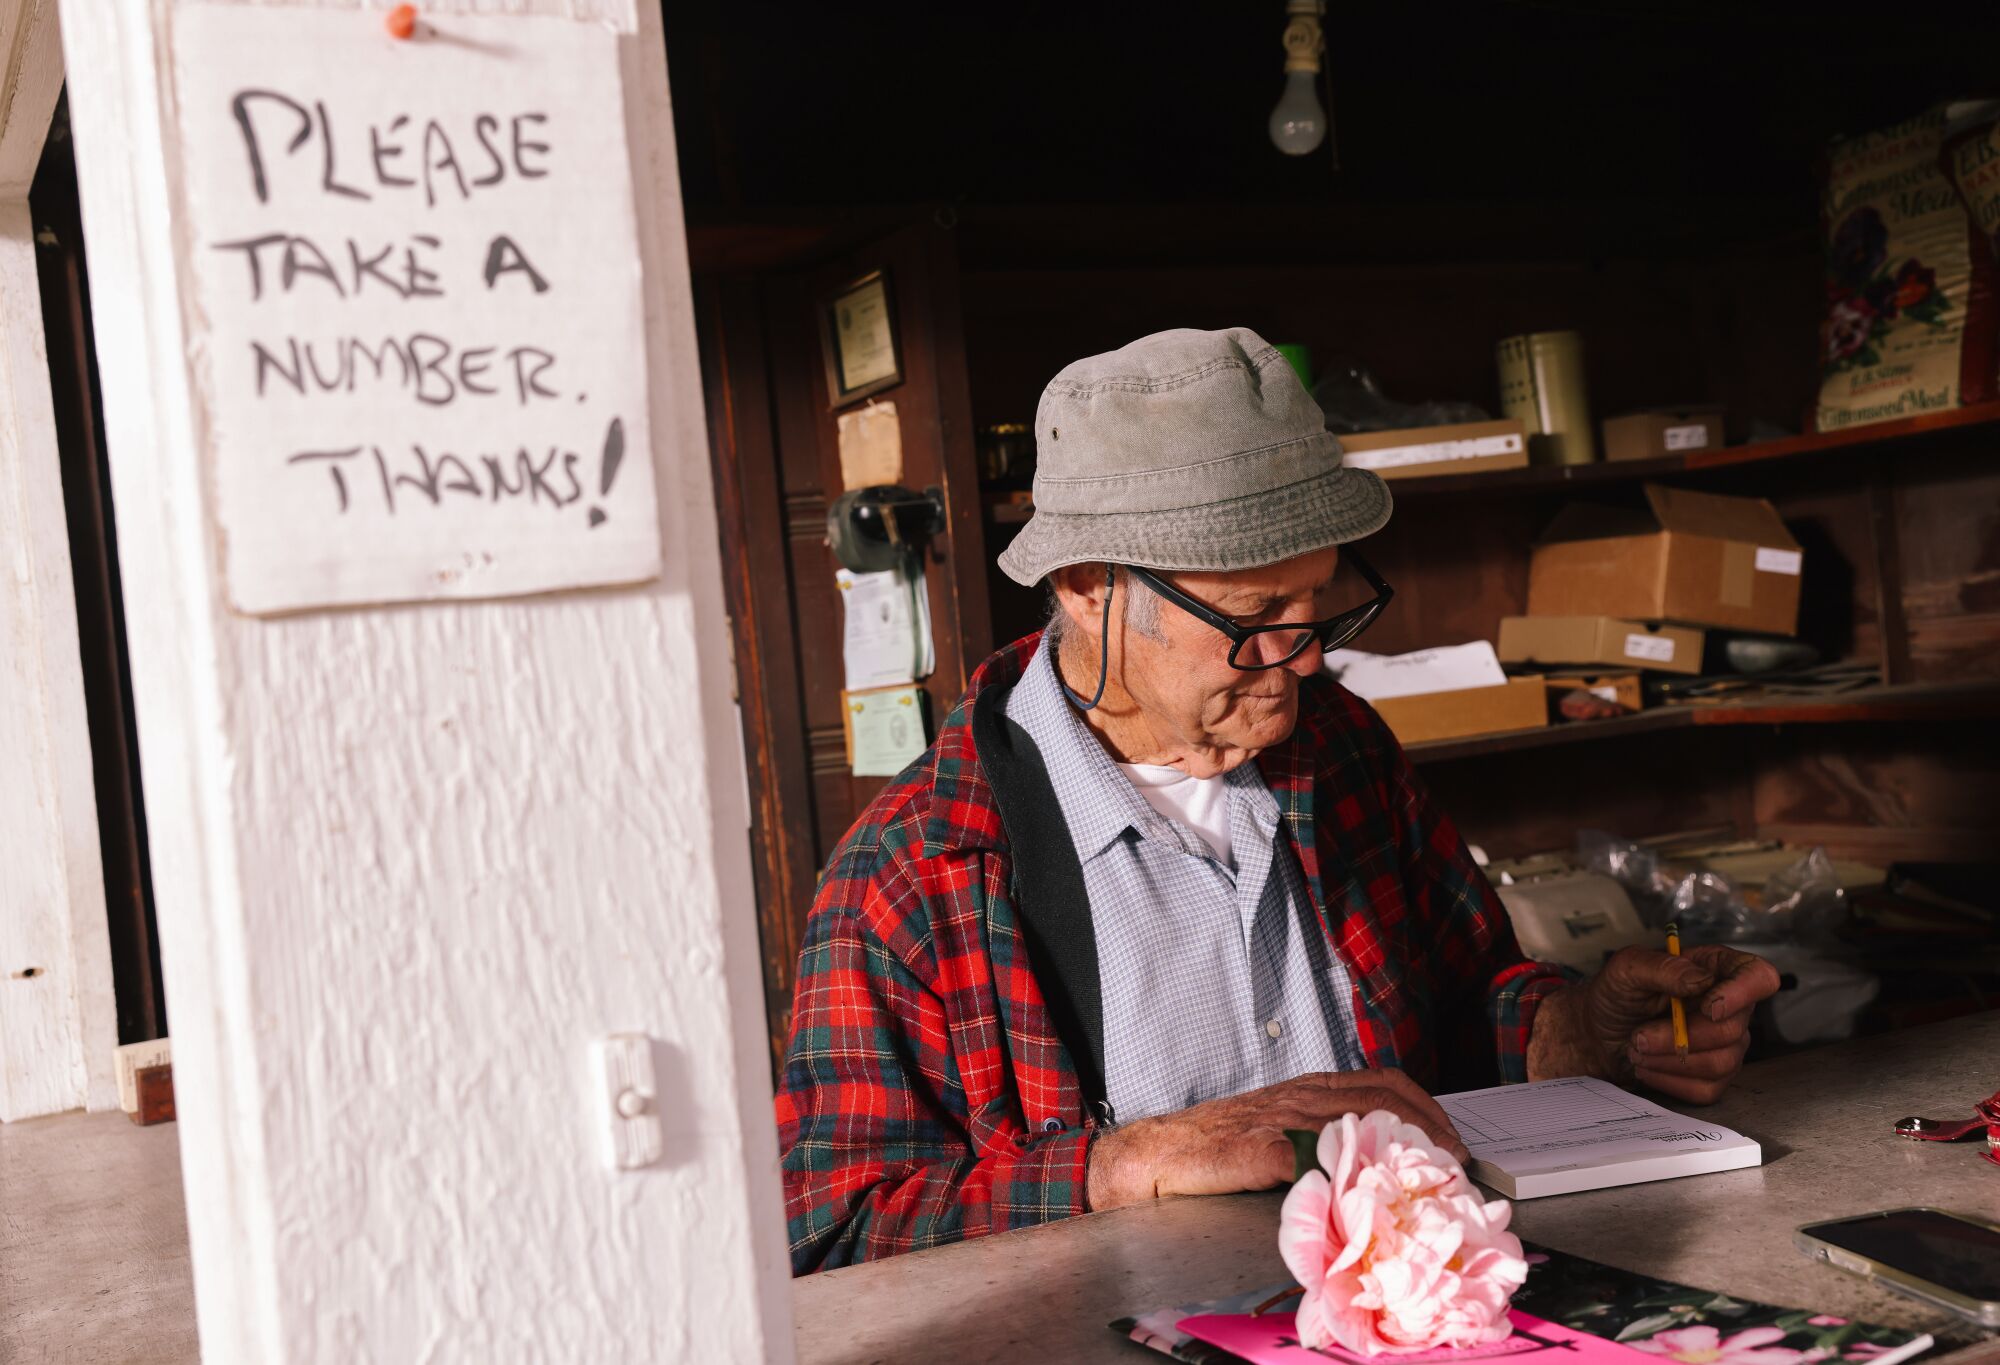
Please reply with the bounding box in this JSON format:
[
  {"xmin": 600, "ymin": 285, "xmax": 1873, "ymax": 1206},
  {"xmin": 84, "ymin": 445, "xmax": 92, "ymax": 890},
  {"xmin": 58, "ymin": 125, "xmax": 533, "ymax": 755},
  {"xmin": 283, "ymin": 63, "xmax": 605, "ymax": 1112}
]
[{"xmin": 778, "ymin": 636, "xmax": 1568, "ymax": 1275}]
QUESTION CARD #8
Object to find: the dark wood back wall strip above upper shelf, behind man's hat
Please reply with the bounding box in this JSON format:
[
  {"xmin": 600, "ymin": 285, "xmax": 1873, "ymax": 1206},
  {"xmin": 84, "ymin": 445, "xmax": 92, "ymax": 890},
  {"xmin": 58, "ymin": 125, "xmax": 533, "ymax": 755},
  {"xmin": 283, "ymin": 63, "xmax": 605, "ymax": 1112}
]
[{"xmin": 964, "ymin": 255, "xmax": 1820, "ymax": 438}]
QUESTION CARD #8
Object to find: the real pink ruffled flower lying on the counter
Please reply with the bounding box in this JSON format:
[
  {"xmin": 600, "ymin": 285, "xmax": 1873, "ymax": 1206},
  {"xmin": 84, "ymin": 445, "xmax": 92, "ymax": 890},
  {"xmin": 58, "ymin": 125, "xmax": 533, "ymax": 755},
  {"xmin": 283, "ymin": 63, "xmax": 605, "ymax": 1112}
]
[{"xmin": 1278, "ymin": 1109, "xmax": 1528, "ymax": 1365}]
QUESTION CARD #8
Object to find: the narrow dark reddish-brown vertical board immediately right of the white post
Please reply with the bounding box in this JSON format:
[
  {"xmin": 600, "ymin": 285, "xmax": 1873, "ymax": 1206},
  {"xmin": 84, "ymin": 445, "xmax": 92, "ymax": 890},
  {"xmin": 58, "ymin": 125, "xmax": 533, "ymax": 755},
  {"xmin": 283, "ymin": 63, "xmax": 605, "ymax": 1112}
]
[{"xmin": 696, "ymin": 278, "xmax": 818, "ymax": 1067}]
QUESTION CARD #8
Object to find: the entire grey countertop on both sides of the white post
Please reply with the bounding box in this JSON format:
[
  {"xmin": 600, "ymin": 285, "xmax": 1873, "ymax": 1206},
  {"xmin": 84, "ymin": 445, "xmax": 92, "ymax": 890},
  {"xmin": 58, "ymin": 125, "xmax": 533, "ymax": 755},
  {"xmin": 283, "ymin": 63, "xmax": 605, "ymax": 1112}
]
[{"xmin": 0, "ymin": 1013, "xmax": 2000, "ymax": 1365}]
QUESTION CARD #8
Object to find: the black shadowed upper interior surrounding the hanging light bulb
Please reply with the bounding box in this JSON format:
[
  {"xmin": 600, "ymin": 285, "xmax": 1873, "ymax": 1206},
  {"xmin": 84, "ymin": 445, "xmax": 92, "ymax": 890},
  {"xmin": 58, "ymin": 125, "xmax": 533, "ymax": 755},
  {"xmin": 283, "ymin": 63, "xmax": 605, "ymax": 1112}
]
[{"xmin": 666, "ymin": 0, "xmax": 1996, "ymax": 235}]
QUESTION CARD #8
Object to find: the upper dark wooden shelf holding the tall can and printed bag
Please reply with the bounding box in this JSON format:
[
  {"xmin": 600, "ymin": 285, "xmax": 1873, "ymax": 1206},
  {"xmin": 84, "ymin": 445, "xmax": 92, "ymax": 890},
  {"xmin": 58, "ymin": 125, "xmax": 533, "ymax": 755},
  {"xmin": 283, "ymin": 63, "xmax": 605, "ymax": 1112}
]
[{"xmin": 1390, "ymin": 402, "xmax": 2000, "ymax": 502}]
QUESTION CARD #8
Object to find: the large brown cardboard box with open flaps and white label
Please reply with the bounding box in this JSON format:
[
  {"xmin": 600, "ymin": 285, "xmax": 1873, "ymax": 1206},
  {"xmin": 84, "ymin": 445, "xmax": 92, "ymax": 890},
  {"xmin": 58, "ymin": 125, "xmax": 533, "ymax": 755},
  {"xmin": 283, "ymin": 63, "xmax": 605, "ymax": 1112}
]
[{"xmin": 1528, "ymin": 484, "xmax": 1802, "ymax": 636}]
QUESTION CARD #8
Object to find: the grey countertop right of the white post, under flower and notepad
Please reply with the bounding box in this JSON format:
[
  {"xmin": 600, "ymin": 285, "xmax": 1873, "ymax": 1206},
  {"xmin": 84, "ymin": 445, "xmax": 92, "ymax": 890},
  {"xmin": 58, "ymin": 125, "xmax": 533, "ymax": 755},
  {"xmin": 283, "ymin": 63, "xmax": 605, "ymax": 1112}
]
[{"xmin": 794, "ymin": 1011, "xmax": 2000, "ymax": 1365}]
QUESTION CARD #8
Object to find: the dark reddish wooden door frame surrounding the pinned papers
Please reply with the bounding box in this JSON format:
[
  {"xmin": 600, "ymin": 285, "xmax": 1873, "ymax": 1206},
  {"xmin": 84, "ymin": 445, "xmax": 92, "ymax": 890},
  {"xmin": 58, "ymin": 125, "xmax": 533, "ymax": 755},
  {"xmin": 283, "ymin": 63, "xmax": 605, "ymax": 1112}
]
[{"xmin": 696, "ymin": 222, "xmax": 992, "ymax": 1067}]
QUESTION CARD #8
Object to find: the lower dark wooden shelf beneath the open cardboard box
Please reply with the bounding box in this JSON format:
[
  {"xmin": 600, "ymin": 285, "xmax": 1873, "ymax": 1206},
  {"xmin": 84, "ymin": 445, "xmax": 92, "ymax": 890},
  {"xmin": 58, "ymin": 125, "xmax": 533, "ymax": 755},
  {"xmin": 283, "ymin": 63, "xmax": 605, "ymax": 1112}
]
[{"xmin": 1408, "ymin": 678, "xmax": 2000, "ymax": 763}]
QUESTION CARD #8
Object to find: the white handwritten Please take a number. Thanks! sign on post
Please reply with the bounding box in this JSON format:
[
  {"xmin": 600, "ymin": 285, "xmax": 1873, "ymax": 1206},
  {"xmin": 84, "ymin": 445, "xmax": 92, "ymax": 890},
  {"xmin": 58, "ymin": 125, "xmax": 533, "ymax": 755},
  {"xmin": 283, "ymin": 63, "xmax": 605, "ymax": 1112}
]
[{"xmin": 172, "ymin": 4, "xmax": 660, "ymax": 612}]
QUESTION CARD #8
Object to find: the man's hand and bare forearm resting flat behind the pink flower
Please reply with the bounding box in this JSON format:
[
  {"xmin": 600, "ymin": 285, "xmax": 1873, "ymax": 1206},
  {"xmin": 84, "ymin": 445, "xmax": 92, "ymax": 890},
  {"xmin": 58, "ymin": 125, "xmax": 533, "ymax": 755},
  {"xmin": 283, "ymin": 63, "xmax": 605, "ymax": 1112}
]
[{"xmin": 1086, "ymin": 1069, "xmax": 1466, "ymax": 1211}]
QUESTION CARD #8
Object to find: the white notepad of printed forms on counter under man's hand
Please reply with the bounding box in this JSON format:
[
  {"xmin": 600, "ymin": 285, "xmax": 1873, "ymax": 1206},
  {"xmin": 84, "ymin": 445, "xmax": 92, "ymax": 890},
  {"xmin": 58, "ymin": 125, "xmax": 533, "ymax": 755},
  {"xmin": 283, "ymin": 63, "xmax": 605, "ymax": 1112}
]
[{"xmin": 1438, "ymin": 1077, "xmax": 1764, "ymax": 1199}]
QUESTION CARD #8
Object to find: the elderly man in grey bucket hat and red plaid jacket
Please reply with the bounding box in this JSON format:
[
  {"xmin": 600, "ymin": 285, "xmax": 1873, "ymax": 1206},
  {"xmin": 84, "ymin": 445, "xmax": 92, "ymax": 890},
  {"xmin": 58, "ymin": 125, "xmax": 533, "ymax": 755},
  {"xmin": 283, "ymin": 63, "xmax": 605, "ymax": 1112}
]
[{"xmin": 778, "ymin": 328, "xmax": 1778, "ymax": 1273}]
